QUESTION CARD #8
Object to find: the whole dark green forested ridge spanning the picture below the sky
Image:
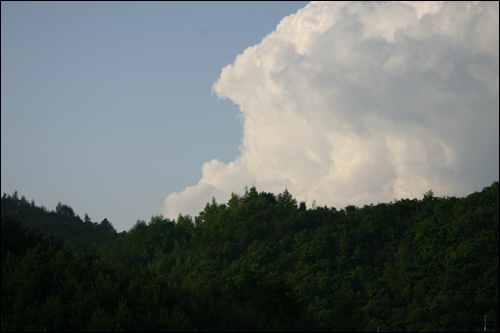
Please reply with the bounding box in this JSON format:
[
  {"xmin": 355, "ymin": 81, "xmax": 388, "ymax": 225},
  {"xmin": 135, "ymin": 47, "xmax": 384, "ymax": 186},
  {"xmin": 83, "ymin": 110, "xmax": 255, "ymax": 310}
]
[{"xmin": 1, "ymin": 182, "xmax": 499, "ymax": 331}]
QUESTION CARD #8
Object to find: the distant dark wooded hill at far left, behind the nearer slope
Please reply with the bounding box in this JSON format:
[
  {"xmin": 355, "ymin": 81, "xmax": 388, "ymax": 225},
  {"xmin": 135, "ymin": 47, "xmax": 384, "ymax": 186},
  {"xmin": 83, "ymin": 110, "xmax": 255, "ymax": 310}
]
[{"xmin": 1, "ymin": 191, "xmax": 116, "ymax": 253}]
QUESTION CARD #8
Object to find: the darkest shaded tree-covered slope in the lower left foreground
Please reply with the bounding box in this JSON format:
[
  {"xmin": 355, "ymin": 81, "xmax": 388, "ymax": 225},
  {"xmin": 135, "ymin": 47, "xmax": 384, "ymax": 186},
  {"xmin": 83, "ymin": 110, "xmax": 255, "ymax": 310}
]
[{"xmin": 2, "ymin": 211, "xmax": 194, "ymax": 331}]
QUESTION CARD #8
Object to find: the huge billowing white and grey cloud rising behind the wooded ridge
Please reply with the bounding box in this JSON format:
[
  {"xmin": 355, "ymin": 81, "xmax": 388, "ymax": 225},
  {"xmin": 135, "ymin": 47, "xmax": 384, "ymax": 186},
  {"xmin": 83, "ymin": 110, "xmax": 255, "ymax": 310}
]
[{"xmin": 163, "ymin": 1, "xmax": 499, "ymax": 218}]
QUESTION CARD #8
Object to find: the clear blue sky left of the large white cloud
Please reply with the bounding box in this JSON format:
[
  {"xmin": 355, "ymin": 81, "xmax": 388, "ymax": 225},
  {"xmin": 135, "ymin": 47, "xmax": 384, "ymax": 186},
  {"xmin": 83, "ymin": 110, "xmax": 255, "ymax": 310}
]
[{"xmin": 1, "ymin": 2, "xmax": 307, "ymax": 230}]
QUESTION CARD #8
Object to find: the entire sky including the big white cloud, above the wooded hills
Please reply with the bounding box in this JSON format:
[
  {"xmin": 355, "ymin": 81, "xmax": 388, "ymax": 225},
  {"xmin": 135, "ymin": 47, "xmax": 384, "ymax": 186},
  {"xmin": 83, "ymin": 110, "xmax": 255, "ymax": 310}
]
[{"xmin": 1, "ymin": 1, "xmax": 499, "ymax": 231}]
